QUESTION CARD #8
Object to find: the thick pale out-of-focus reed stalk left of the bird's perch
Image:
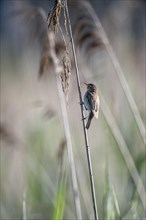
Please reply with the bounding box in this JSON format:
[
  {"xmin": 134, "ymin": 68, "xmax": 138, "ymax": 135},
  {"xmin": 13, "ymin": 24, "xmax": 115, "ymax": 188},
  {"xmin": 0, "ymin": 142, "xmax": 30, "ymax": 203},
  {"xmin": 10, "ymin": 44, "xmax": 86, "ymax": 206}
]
[{"xmin": 48, "ymin": 32, "xmax": 82, "ymax": 219}]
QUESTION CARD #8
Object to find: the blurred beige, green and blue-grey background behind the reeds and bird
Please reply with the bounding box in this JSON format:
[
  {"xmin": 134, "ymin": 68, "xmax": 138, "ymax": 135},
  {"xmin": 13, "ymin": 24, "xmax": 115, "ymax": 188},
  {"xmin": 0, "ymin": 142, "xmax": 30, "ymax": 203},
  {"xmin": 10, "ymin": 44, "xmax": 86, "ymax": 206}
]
[{"xmin": 0, "ymin": 0, "xmax": 146, "ymax": 220}]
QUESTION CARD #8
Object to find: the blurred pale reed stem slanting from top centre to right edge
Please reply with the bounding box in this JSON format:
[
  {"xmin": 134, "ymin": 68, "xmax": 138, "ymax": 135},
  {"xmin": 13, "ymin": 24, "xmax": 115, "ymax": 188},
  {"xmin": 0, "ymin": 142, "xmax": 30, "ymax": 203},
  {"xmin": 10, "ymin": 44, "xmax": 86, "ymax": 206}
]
[{"xmin": 81, "ymin": 1, "xmax": 146, "ymax": 147}]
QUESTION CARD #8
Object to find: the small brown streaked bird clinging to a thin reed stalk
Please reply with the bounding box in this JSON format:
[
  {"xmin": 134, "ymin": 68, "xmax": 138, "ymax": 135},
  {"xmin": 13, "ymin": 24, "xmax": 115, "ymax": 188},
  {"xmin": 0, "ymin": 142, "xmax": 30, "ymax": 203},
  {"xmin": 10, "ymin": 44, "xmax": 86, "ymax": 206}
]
[{"xmin": 84, "ymin": 83, "xmax": 99, "ymax": 129}]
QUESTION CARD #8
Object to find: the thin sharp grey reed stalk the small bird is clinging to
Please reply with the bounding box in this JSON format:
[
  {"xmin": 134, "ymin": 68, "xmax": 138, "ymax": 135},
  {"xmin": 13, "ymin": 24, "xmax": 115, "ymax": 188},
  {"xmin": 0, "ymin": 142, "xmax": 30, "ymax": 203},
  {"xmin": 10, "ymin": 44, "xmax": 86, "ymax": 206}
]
[{"xmin": 65, "ymin": 0, "xmax": 98, "ymax": 220}]
